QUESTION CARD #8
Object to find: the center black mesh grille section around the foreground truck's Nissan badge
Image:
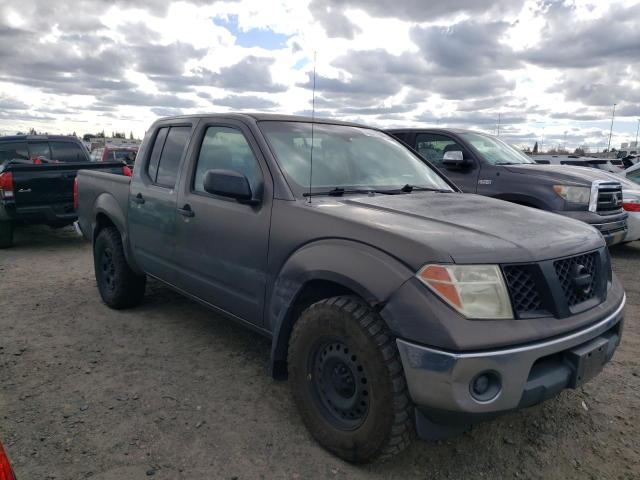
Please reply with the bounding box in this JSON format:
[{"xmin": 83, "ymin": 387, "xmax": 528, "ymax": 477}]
[{"xmin": 553, "ymin": 252, "xmax": 598, "ymax": 307}]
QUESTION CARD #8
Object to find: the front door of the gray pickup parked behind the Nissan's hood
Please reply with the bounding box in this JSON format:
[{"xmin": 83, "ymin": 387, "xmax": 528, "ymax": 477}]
[{"xmin": 415, "ymin": 133, "xmax": 480, "ymax": 193}]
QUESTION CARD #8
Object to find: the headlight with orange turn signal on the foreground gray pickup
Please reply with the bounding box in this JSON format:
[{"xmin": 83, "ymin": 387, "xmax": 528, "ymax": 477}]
[{"xmin": 417, "ymin": 265, "xmax": 513, "ymax": 319}]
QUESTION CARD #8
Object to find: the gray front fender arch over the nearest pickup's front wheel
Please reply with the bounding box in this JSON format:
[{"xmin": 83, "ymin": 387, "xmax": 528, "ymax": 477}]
[{"xmin": 266, "ymin": 238, "xmax": 415, "ymax": 377}]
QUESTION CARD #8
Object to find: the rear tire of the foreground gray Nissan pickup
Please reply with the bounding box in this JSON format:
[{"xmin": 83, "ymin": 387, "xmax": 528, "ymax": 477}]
[{"xmin": 93, "ymin": 227, "xmax": 147, "ymax": 310}]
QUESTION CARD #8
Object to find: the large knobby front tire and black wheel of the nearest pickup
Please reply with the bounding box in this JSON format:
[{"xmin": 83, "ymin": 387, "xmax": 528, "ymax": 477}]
[{"xmin": 289, "ymin": 296, "xmax": 414, "ymax": 463}]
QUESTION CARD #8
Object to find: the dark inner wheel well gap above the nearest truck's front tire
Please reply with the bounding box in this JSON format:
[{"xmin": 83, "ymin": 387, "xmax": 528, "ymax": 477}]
[{"xmin": 271, "ymin": 280, "xmax": 358, "ymax": 380}]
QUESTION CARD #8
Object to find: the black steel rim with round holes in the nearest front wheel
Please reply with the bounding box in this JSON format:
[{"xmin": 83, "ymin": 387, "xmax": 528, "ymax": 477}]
[{"xmin": 310, "ymin": 340, "xmax": 370, "ymax": 430}]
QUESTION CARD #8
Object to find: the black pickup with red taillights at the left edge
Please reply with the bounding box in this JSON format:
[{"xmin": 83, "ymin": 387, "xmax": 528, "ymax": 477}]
[{"xmin": 0, "ymin": 135, "xmax": 130, "ymax": 248}]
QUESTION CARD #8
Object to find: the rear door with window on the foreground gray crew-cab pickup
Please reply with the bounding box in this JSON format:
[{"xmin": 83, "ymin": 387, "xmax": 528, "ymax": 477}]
[{"xmin": 128, "ymin": 123, "xmax": 193, "ymax": 283}]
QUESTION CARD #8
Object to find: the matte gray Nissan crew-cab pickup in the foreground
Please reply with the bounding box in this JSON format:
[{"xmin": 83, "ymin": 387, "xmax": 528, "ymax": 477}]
[{"xmin": 78, "ymin": 114, "xmax": 625, "ymax": 462}]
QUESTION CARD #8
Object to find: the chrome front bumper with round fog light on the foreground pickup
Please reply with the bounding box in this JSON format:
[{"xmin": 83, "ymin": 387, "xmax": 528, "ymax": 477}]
[{"xmin": 397, "ymin": 297, "xmax": 625, "ymax": 416}]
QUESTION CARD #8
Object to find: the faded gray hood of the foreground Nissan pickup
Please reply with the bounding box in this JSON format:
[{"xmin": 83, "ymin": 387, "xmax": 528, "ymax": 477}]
[{"xmin": 319, "ymin": 192, "xmax": 604, "ymax": 267}]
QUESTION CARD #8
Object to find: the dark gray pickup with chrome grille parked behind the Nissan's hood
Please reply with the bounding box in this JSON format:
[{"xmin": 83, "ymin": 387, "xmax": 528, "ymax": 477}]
[{"xmin": 389, "ymin": 128, "xmax": 627, "ymax": 245}]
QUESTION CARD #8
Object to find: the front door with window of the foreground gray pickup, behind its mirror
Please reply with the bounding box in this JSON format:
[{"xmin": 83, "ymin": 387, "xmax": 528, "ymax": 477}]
[{"xmin": 176, "ymin": 120, "xmax": 273, "ymax": 325}]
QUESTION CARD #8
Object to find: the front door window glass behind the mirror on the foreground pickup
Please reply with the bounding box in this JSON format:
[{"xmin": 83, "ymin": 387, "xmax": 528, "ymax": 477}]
[{"xmin": 193, "ymin": 127, "xmax": 262, "ymax": 196}]
